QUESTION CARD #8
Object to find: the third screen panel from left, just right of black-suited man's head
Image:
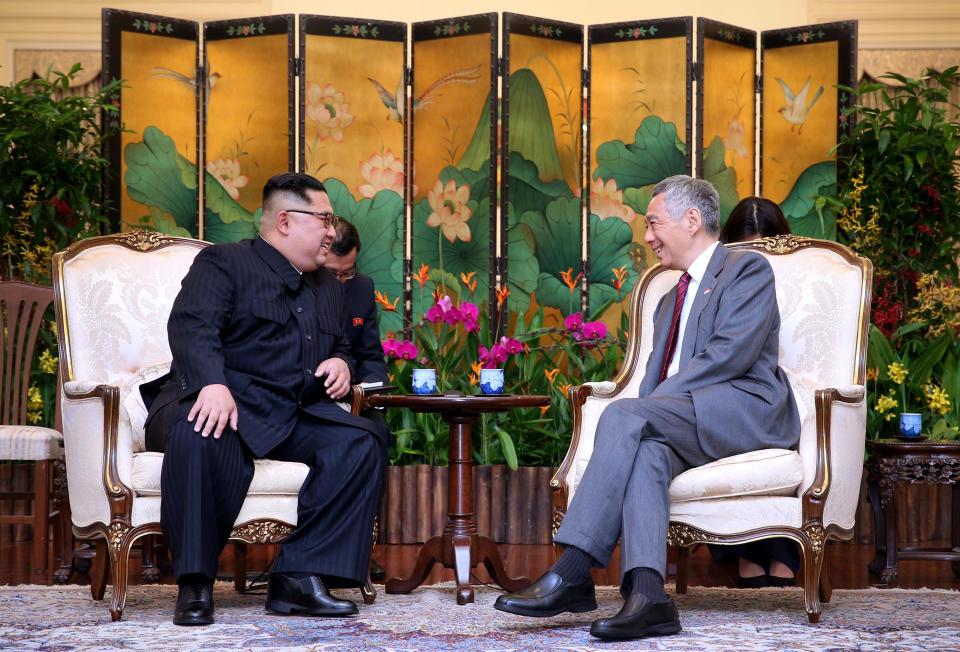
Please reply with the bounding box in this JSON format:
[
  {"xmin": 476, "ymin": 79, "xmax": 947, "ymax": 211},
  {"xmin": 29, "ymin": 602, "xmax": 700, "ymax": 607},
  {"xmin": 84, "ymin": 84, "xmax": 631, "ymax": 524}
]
[{"xmin": 300, "ymin": 16, "xmax": 407, "ymax": 333}]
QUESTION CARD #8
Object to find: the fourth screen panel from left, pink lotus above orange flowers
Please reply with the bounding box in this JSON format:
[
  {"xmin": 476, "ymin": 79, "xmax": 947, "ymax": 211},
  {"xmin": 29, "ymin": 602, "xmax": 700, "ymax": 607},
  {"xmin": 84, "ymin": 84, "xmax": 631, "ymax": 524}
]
[{"xmin": 410, "ymin": 14, "xmax": 499, "ymax": 321}]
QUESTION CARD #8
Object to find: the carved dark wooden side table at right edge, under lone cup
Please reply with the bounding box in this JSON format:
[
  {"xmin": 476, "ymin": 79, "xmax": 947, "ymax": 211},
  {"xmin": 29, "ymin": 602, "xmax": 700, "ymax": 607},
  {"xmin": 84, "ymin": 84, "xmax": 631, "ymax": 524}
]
[{"xmin": 867, "ymin": 439, "xmax": 960, "ymax": 583}]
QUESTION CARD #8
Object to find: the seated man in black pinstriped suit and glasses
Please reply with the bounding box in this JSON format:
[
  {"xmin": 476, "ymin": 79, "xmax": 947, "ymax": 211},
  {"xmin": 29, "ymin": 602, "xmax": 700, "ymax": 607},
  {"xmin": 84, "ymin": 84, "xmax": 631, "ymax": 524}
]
[{"xmin": 144, "ymin": 173, "xmax": 386, "ymax": 625}]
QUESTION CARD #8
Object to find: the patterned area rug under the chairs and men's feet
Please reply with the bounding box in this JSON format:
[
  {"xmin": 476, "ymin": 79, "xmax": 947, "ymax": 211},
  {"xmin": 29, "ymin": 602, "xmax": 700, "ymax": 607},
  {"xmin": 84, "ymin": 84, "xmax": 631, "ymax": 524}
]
[{"xmin": 0, "ymin": 583, "xmax": 960, "ymax": 652}]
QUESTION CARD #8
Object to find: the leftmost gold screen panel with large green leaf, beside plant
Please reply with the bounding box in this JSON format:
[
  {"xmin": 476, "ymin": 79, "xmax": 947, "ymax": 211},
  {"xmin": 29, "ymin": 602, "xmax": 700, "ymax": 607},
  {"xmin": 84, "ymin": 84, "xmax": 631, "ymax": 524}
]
[{"xmin": 102, "ymin": 9, "xmax": 200, "ymax": 237}]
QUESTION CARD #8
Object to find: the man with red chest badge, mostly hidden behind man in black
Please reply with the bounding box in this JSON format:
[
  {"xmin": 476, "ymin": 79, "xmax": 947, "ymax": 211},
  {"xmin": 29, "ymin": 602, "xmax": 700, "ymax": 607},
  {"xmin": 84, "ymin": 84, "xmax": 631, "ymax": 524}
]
[{"xmin": 324, "ymin": 219, "xmax": 390, "ymax": 581}]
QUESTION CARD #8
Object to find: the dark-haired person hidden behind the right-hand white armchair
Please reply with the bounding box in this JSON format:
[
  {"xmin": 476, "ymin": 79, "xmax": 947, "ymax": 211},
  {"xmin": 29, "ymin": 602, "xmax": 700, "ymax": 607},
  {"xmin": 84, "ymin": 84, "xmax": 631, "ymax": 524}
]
[{"xmin": 709, "ymin": 197, "xmax": 800, "ymax": 588}]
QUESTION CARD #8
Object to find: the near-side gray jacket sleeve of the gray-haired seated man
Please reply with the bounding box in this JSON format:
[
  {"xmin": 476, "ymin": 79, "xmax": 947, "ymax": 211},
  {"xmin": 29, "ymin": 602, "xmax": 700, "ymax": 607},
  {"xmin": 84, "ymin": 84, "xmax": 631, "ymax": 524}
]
[{"xmin": 654, "ymin": 255, "xmax": 780, "ymax": 395}]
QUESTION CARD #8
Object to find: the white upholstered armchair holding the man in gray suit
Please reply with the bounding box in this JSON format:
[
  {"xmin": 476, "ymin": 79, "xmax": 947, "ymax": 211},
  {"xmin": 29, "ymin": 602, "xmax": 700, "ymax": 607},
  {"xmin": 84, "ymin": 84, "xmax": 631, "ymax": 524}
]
[{"xmin": 551, "ymin": 236, "xmax": 873, "ymax": 622}]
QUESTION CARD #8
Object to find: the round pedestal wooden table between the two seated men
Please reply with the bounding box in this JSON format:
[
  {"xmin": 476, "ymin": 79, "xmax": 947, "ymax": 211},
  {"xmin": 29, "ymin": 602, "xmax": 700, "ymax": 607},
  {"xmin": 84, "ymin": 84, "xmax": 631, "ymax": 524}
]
[{"xmin": 370, "ymin": 393, "xmax": 550, "ymax": 605}]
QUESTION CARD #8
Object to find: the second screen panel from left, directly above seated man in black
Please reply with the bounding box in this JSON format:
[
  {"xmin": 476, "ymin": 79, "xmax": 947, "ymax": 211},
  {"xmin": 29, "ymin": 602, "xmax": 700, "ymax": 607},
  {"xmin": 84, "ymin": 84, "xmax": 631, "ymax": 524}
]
[{"xmin": 202, "ymin": 14, "xmax": 295, "ymax": 242}]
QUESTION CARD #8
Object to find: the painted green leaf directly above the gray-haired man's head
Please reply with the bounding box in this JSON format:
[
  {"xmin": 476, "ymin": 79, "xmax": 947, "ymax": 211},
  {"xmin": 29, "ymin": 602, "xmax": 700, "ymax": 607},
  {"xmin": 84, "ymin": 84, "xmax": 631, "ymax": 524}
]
[{"xmin": 596, "ymin": 114, "xmax": 687, "ymax": 189}]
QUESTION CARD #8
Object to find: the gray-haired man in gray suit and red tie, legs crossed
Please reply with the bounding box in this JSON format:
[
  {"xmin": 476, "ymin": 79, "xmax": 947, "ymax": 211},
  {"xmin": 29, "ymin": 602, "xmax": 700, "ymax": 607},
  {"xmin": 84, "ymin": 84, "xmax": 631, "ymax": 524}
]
[{"xmin": 495, "ymin": 175, "xmax": 800, "ymax": 639}]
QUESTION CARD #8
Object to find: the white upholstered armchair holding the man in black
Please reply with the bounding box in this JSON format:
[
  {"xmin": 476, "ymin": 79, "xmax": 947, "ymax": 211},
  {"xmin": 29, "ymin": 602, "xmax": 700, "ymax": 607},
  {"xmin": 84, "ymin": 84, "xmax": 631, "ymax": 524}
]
[{"xmin": 53, "ymin": 231, "xmax": 376, "ymax": 620}]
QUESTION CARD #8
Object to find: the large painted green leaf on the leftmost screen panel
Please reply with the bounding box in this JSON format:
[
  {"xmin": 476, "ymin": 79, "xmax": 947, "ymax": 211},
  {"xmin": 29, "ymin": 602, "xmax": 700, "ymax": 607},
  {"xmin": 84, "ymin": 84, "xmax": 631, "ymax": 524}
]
[{"xmin": 123, "ymin": 126, "xmax": 197, "ymax": 237}]
